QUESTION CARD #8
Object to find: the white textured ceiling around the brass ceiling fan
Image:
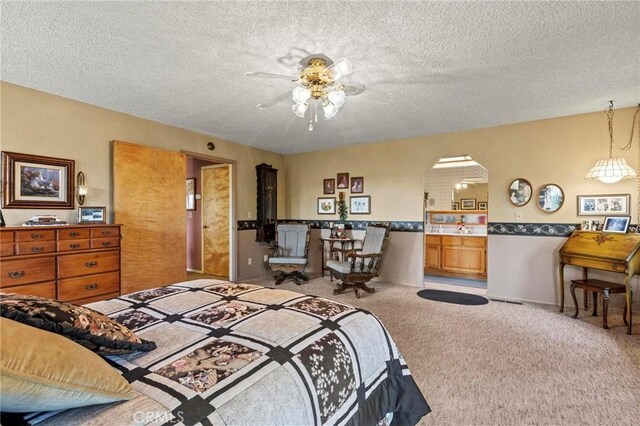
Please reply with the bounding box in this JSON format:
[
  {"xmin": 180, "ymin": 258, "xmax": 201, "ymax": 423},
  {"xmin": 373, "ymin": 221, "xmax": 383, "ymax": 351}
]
[{"xmin": 0, "ymin": 1, "xmax": 640, "ymax": 153}]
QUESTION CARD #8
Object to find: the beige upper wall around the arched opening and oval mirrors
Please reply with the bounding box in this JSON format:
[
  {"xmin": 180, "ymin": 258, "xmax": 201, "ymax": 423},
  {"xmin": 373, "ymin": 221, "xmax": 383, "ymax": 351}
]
[{"xmin": 285, "ymin": 108, "xmax": 639, "ymax": 223}]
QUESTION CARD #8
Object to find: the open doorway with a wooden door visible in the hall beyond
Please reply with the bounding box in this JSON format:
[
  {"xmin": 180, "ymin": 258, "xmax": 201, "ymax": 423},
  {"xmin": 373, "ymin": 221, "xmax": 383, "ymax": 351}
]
[{"xmin": 186, "ymin": 155, "xmax": 236, "ymax": 281}]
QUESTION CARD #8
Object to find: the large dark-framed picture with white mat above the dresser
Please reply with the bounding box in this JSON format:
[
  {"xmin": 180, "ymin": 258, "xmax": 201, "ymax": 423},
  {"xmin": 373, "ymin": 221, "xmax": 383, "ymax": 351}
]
[{"xmin": 2, "ymin": 151, "xmax": 75, "ymax": 209}]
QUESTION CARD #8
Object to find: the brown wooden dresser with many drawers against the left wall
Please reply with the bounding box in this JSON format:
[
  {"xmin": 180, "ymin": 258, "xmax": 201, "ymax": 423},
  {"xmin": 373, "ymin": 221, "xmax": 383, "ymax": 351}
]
[{"xmin": 0, "ymin": 225, "xmax": 120, "ymax": 304}]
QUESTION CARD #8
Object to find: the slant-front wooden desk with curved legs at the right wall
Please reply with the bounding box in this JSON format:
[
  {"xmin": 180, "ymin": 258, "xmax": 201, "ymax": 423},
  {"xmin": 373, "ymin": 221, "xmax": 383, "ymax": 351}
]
[{"xmin": 559, "ymin": 231, "xmax": 640, "ymax": 334}]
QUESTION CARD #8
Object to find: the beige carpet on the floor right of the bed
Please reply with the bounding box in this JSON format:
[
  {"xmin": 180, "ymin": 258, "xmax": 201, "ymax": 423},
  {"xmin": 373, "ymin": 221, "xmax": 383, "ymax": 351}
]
[{"xmin": 195, "ymin": 278, "xmax": 640, "ymax": 425}]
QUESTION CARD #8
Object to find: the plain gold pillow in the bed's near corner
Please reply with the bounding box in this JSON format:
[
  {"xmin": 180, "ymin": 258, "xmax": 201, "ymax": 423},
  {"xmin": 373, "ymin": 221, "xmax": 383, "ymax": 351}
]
[{"xmin": 0, "ymin": 318, "xmax": 136, "ymax": 413}]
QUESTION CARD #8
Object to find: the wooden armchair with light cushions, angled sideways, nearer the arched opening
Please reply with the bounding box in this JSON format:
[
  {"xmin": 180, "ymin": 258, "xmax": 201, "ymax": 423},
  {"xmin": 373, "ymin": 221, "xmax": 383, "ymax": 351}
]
[{"xmin": 327, "ymin": 225, "xmax": 389, "ymax": 298}]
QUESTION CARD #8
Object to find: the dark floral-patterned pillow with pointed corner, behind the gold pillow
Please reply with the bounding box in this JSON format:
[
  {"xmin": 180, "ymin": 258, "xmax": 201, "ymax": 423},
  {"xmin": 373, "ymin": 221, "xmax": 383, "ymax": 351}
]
[{"xmin": 0, "ymin": 293, "xmax": 156, "ymax": 355}]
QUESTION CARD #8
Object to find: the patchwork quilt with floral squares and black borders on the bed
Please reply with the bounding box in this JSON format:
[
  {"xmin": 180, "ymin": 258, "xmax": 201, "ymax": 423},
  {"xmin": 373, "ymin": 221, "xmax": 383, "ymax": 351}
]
[{"xmin": 11, "ymin": 280, "xmax": 430, "ymax": 425}]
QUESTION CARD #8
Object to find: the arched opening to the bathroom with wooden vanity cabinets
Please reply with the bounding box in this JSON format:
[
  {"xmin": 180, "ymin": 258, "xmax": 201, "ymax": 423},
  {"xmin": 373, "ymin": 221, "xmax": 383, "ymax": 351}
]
[{"xmin": 424, "ymin": 155, "xmax": 490, "ymax": 294}]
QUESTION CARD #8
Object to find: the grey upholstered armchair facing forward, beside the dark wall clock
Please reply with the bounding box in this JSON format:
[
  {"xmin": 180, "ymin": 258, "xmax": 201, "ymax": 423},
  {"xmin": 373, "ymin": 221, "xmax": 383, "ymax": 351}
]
[{"xmin": 269, "ymin": 223, "xmax": 309, "ymax": 285}]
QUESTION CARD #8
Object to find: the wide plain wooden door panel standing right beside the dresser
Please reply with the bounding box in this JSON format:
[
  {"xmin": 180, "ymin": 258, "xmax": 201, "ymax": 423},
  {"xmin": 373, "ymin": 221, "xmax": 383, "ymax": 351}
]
[{"xmin": 113, "ymin": 141, "xmax": 187, "ymax": 294}]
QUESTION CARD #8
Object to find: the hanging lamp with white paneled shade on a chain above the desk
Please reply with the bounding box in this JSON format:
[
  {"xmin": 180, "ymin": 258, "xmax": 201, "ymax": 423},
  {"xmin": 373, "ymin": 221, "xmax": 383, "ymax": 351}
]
[{"xmin": 585, "ymin": 101, "xmax": 640, "ymax": 183}]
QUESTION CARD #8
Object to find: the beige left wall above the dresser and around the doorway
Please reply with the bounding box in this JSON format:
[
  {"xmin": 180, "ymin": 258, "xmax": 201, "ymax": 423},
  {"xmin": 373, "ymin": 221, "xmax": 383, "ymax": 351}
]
[{"xmin": 0, "ymin": 82, "xmax": 287, "ymax": 278}]
